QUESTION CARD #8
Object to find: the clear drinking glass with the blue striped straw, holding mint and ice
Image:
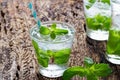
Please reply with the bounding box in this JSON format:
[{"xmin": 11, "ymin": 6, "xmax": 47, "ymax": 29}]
[{"xmin": 30, "ymin": 21, "xmax": 75, "ymax": 78}]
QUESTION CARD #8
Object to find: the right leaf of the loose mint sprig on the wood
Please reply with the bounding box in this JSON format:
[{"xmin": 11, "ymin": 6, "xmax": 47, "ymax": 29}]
[{"xmin": 92, "ymin": 63, "xmax": 112, "ymax": 77}]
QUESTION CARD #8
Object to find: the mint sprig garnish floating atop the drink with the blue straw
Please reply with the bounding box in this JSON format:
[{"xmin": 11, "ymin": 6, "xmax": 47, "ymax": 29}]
[{"xmin": 39, "ymin": 23, "xmax": 68, "ymax": 39}]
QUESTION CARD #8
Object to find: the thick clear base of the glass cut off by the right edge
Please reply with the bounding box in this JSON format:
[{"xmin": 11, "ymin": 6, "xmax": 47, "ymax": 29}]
[{"xmin": 106, "ymin": 54, "xmax": 120, "ymax": 65}]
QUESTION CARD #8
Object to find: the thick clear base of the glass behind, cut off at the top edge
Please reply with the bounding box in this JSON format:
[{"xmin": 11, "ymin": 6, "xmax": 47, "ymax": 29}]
[{"xmin": 87, "ymin": 29, "xmax": 109, "ymax": 41}]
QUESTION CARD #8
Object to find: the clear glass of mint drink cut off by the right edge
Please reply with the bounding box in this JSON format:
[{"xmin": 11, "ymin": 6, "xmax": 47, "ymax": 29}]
[{"xmin": 106, "ymin": 0, "xmax": 120, "ymax": 64}]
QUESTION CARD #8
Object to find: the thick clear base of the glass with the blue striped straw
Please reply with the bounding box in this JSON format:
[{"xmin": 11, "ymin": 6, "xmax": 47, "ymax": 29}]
[{"xmin": 40, "ymin": 64, "xmax": 67, "ymax": 78}]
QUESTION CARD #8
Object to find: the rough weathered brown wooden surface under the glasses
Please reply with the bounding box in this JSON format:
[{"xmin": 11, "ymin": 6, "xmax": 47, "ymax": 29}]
[{"xmin": 0, "ymin": 0, "xmax": 120, "ymax": 80}]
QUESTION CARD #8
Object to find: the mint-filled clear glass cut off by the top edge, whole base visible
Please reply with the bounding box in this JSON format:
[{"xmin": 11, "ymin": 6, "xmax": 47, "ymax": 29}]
[{"xmin": 83, "ymin": 0, "xmax": 111, "ymax": 41}]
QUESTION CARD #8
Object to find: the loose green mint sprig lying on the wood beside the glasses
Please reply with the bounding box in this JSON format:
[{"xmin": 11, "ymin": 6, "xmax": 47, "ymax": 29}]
[{"xmin": 63, "ymin": 57, "xmax": 112, "ymax": 80}]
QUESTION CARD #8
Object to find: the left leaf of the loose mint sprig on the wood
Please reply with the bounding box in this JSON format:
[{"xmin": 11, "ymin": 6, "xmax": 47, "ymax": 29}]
[{"xmin": 62, "ymin": 66, "xmax": 86, "ymax": 80}]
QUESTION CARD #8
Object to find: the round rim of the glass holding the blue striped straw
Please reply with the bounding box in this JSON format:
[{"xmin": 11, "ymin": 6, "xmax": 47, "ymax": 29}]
[{"xmin": 29, "ymin": 21, "xmax": 75, "ymax": 43}]
